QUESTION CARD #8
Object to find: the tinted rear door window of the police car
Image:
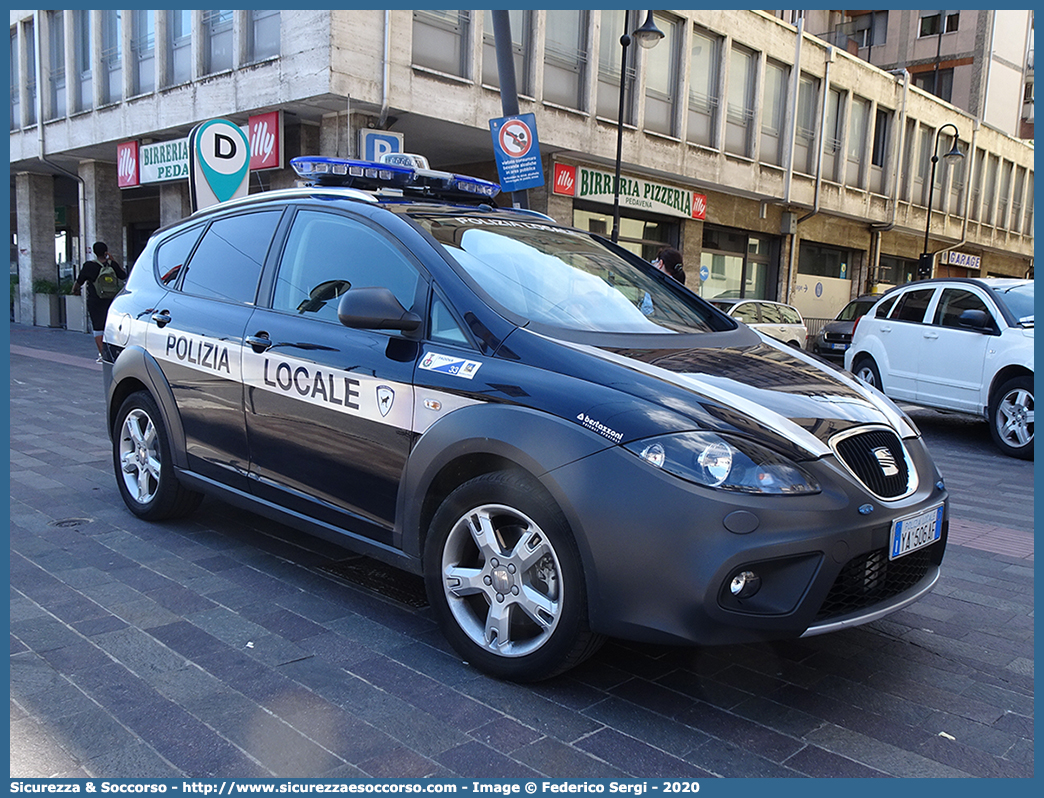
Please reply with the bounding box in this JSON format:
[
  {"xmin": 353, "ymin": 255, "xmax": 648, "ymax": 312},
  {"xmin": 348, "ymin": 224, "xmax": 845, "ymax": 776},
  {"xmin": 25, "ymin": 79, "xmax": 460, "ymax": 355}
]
[{"xmin": 181, "ymin": 211, "xmax": 282, "ymax": 304}]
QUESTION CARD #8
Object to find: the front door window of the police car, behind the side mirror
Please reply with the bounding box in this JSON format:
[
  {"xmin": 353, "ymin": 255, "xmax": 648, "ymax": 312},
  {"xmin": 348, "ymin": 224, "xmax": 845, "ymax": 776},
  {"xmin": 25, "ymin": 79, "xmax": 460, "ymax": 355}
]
[{"xmin": 272, "ymin": 210, "xmax": 421, "ymax": 322}]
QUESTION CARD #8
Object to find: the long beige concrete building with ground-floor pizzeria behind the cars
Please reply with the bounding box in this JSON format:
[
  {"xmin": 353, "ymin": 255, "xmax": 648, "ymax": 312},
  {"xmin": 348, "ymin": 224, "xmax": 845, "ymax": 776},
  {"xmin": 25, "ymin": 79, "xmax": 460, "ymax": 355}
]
[{"xmin": 10, "ymin": 9, "xmax": 1034, "ymax": 322}]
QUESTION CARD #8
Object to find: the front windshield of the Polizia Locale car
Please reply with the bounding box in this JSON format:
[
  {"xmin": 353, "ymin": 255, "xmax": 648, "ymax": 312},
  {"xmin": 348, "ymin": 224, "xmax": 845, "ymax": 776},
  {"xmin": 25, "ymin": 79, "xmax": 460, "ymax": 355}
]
[{"xmin": 414, "ymin": 215, "xmax": 729, "ymax": 333}]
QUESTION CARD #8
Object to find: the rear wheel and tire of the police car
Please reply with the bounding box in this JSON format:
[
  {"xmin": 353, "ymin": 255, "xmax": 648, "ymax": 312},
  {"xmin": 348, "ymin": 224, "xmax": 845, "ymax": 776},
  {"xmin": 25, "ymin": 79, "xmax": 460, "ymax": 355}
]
[{"xmin": 113, "ymin": 391, "xmax": 203, "ymax": 521}]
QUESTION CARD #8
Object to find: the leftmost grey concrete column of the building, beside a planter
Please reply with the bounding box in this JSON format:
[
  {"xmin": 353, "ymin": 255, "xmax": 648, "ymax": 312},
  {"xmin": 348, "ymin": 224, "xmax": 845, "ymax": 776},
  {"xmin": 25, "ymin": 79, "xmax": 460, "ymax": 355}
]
[{"xmin": 15, "ymin": 172, "xmax": 58, "ymax": 324}]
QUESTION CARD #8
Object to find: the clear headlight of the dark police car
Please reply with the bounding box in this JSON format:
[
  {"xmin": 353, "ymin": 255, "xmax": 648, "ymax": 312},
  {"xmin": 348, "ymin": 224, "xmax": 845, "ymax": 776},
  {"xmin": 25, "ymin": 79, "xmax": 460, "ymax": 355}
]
[{"xmin": 624, "ymin": 431, "xmax": 820, "ymax": 496}]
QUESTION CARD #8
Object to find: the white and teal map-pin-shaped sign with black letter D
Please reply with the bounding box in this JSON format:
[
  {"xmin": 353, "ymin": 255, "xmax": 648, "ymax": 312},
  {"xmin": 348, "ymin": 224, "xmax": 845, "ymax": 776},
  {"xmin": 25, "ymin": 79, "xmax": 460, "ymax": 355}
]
[{"xmin": 189, "ymin": 119, "xmax": 251, "ymax": 211}]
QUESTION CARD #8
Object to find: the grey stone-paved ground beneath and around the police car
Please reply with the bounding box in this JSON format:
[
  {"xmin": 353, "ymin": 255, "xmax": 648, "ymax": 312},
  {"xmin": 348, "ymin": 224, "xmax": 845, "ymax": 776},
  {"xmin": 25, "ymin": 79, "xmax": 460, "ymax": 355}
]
[{"xmin": 9, "ymin": 326, "xmax": 1035, "ymax": 789}]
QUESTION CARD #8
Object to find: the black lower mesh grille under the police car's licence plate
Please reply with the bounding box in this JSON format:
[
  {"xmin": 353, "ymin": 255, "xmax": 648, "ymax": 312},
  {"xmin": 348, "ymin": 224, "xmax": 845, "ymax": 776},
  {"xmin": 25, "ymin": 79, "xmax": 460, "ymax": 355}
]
[{"xmin": 813, "ymin": 543, "xmax": 939, "ymax": 624}]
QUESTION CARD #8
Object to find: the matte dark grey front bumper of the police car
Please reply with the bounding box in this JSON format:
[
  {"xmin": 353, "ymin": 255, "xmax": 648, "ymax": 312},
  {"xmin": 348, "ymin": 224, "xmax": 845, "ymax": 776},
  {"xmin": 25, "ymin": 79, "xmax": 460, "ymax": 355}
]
[{"xmin": 547, "ymin": 440, "xmax": 949, "ymax": 644}]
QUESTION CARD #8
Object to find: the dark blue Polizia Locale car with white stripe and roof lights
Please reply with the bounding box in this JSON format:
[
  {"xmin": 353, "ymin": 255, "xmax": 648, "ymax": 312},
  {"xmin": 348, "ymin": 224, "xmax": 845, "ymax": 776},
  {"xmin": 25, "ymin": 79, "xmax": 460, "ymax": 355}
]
[{"xmin": 104, "ymin": 158, "xmax": 948, "ymax": 681}]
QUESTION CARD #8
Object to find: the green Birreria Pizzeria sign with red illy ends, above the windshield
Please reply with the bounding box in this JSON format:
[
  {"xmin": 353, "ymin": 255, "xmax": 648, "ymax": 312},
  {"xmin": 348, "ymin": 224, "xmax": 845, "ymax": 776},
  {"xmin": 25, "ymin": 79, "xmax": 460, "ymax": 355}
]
[{"xmin": 552, "ymin": 163, "xmax": 707, "ymax": 219}]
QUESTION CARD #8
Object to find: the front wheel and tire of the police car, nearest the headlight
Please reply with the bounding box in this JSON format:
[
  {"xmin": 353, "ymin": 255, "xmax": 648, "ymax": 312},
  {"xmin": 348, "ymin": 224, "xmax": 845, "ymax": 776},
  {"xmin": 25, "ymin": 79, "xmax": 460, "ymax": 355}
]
[{"xmin": 424, "ymin": 471, "xmax": 602, "ymax": 682}]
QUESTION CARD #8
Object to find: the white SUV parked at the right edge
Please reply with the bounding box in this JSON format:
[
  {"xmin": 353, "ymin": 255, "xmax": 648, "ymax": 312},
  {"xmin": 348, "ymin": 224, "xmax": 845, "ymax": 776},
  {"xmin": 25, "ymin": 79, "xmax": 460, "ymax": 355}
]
[{"xmin": 845, "ymin": 278, "xmax": 1034, "ymax": 460}]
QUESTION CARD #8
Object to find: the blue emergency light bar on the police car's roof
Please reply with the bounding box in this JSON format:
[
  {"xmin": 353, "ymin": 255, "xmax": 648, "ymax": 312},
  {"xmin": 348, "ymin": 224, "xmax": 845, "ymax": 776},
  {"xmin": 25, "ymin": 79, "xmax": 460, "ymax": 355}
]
[{"xmin": 290, "ymin": 156, "xmax": 500, "ymax": 202}]
